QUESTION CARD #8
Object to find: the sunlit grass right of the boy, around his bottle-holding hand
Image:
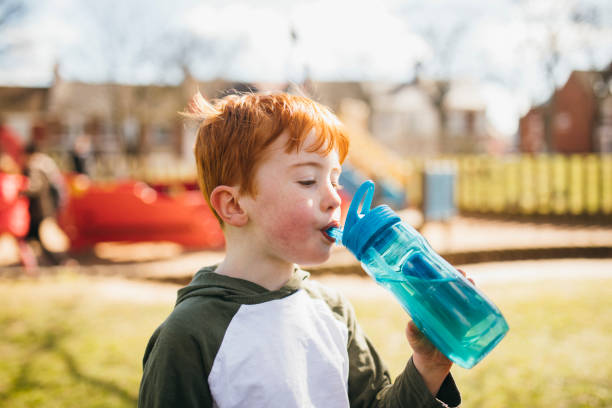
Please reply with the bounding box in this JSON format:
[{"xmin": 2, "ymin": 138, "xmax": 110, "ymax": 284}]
[{"xmin": 355, "ymin": 279, "xmax": 612, "ymax": 408}]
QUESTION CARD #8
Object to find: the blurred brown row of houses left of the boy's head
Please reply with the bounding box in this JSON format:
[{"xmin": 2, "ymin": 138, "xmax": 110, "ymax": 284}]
[{"xmin": 0, "ymin": 66, "xmax": 243, "ymax": 163}]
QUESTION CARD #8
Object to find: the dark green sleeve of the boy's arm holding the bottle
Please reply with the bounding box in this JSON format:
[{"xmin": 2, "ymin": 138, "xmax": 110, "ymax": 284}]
[{"xmin": 345, "ymin": 303, "xmax": 461, "ymax": 408}]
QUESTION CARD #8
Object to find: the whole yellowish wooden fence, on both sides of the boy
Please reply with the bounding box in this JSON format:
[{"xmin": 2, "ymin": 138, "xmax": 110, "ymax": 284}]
[{"xmin": 55, "ymin": 154, "xmax": 612, "ymax": 216}]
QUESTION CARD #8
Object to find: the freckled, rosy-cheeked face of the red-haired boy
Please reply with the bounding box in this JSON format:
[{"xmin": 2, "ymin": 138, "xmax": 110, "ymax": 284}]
[{"xmin": 241, "ymin": 129, "xmax": 341, "ymax": 265}]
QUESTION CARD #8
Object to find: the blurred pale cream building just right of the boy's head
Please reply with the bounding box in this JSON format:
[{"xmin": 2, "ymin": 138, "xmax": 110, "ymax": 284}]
[{"xmin": 367, "ymin": 80, "xmax": 494, "ymax": 156}]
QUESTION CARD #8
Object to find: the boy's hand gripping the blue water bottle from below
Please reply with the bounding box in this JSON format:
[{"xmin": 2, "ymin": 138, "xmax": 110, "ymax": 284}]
[{"xmin": 406, "ymin": 269, "xmax": 474, "ymax": 395}]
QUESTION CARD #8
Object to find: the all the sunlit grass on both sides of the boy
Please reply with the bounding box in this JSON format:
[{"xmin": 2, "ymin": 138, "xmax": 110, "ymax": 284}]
[{"xmin": 0, "ymin": 275, "xmax": 612, "ymax": 407}]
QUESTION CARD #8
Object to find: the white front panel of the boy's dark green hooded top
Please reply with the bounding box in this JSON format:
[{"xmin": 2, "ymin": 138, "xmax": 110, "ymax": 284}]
[{"xmin": 208, "ymin": 290, "xmax": 349, "ymax": 408}]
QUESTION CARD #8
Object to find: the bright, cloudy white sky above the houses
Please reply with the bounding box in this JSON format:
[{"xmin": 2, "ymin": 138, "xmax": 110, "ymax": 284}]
[{"xmin": 0, "ymin": 0, "xmax": 612, "ymax": 136}]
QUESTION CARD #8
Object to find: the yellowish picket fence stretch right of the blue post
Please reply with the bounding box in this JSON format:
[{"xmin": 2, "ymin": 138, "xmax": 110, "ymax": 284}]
[{"xmin": 451, "ymin": 155, "xmax": 612, "ymax": 215}]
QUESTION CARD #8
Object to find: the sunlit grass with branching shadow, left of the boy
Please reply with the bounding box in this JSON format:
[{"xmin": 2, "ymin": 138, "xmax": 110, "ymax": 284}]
[{"xmin": 0, "ymin": 277, "xmax": 172, "ymax": 407}]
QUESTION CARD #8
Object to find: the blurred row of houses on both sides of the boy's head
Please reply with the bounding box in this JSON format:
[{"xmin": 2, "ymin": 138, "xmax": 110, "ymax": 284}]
[{"xmin": 0, "ymin": 66, "xmax": 506, "ymax": 178}]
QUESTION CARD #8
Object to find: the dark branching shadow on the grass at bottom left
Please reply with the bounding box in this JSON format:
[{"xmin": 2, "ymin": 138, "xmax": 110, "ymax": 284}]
[{"xmin": 0, "ymin": 318, "xmax": 137, "ymax": 406}]
